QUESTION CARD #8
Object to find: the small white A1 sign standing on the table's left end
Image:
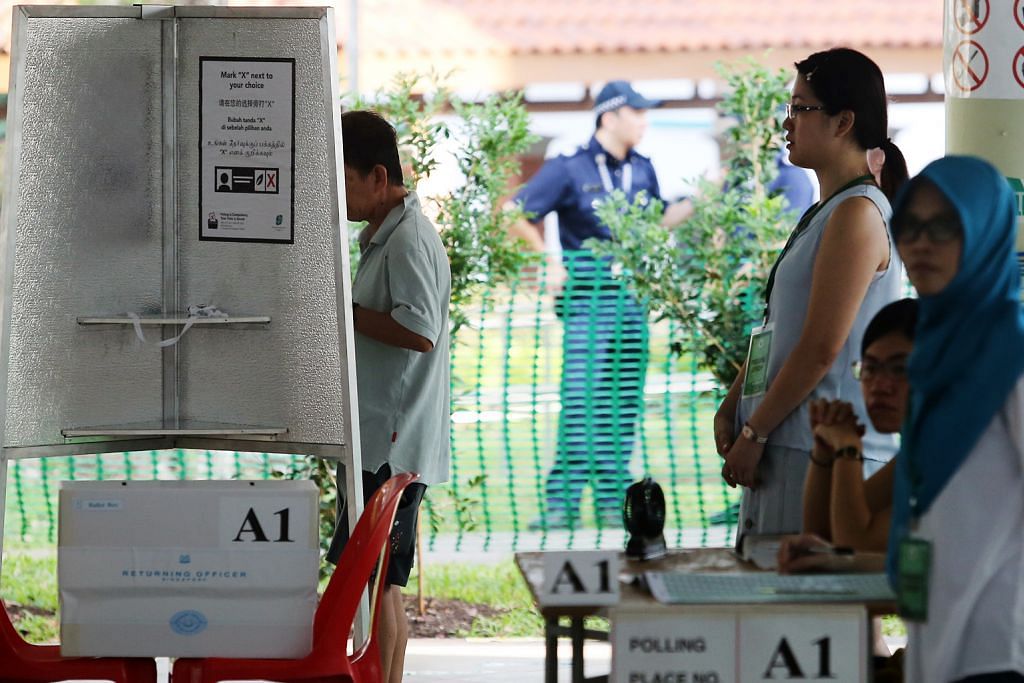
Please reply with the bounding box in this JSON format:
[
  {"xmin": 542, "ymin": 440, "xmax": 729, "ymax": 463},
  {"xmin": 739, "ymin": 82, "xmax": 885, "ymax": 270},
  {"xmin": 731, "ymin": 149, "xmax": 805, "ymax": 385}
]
[{"xmin": 538, "ymin": 550, "xmax": 618, "ymax": 606}]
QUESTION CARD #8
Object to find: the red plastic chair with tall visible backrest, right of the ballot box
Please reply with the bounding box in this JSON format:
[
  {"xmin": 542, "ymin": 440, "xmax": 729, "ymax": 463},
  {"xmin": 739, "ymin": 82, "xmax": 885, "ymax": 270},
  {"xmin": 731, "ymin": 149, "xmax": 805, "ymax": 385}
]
[{"xmin": 171, "ymin": 473, "xmax": 420, "ymax": 683}]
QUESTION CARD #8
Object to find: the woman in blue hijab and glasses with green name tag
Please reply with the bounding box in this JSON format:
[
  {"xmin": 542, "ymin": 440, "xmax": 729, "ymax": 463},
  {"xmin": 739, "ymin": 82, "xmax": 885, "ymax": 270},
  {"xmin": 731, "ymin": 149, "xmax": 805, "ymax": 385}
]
[{"xmin": 888, "ymin": 157, "xmax": 1024, "ymax": 683}]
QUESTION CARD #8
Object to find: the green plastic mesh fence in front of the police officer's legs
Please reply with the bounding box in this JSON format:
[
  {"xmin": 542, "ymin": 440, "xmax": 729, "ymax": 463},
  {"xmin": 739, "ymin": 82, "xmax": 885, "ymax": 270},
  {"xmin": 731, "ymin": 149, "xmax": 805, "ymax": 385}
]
[{"xmin": 5, "ymin": 254, "xmax": 738, "ymax": 550}]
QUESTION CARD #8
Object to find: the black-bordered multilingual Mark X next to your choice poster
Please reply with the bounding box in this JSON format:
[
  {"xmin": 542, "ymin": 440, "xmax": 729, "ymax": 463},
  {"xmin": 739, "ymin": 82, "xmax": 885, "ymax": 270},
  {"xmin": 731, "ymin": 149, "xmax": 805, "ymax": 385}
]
[{"xmin": 199, "ymin": 57, "xmax": 295, "ymax": 244}]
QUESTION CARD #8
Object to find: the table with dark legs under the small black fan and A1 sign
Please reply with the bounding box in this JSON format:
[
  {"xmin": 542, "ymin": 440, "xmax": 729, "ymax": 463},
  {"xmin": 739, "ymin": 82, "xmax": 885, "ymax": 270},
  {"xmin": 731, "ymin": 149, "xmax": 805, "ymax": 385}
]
[{"xmin": 515, "ymin": 548, "xmax": 895, "ymax": 683}]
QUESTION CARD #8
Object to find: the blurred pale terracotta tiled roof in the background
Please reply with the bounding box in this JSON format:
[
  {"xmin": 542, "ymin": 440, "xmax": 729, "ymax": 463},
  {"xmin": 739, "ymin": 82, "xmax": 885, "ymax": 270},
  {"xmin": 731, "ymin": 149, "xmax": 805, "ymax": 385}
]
[{"xmin": 352, "ymin": 0, "xmax": 944, "ymax": 55}]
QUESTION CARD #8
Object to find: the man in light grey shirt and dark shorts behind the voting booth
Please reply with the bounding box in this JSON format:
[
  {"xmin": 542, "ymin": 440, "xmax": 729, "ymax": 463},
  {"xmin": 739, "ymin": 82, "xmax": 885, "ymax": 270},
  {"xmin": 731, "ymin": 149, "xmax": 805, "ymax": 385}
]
[{"xmin": 332, "ymin": 112, "xmax": 452, "ymax": 683}]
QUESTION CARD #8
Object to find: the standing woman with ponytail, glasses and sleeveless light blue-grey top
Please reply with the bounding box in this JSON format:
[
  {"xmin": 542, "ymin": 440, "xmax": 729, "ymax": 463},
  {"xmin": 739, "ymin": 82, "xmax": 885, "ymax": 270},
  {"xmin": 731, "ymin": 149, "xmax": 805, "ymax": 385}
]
[{"xmin": 715, "ymin": 48, "xmax": 907, "ymax": 536}]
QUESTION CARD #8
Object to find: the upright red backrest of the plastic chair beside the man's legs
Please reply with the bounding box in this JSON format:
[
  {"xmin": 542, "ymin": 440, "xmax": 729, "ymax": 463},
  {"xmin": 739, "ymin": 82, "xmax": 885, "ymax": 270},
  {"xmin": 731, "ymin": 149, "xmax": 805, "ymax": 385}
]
[{"xmin": 313, "ymin": 472, "xmax": 420, "ymax": 651}]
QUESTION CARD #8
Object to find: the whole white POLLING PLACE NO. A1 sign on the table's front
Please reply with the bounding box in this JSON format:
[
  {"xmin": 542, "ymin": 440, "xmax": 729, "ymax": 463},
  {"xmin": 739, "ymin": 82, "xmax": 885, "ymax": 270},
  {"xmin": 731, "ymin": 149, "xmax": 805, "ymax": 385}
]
[{"xmin": 610, "ymin": 604, "xmax": 869, "ymax": 683}]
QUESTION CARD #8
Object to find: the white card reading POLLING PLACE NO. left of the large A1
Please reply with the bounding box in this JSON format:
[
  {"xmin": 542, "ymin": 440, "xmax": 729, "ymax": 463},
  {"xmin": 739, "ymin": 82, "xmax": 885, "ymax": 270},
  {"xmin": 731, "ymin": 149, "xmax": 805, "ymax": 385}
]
[{"xmin": 611, "ymin": 609, "xmax": 736, "ymax": 683}]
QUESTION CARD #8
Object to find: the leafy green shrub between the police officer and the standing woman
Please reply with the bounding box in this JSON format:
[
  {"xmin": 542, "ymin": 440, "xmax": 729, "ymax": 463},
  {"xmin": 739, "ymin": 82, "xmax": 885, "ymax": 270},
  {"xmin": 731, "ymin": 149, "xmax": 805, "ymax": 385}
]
[{"xmin": 588, "ymin": 59, "xmax": 793, "ymax": 385}]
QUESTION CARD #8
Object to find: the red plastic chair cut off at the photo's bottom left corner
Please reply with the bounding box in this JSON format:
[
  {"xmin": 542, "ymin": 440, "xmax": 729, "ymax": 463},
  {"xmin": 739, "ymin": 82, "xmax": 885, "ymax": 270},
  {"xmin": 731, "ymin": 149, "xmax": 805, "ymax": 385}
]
[{"xmin": 0, "ymin": 600, "xmax": 157, "ymax": 683}]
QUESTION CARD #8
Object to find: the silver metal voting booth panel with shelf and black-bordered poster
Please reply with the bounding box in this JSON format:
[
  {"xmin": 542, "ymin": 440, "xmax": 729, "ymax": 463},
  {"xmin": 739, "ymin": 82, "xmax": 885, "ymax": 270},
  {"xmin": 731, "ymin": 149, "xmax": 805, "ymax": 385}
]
[{"xmin": 0, "ymin": 6, "xmax": 361, "ymax": 565}]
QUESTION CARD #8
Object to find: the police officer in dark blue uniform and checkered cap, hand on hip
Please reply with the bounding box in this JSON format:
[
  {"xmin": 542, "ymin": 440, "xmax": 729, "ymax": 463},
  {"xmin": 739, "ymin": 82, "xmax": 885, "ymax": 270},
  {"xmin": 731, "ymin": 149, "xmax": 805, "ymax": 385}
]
[{"xmin": 512, "ymin": 81, "xmax": 688, "ymax": 529}]
